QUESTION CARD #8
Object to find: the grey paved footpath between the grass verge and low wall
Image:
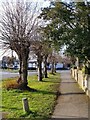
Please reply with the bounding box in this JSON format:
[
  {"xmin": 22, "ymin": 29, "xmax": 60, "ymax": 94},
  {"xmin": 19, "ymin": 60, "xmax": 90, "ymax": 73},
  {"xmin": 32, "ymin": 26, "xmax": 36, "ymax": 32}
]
[{"xmin": 52, "ymin": 71, "xmax": 89, "ymax": 120}]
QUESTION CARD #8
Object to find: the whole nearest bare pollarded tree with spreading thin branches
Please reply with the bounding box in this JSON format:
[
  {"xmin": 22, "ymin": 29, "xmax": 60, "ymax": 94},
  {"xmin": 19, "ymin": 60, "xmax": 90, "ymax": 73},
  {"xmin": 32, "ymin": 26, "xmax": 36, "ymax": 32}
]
[{"xmin": 0, "ymin": 0, "xmax": 40, "ymax": 88}]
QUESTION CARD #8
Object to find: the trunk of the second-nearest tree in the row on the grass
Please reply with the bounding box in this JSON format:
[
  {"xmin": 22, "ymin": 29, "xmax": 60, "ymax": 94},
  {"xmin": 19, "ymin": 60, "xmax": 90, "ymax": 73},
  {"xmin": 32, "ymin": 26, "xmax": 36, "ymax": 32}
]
[{"xmin": 37, "ymin": 56, "xmax": 42, "ymax": 81}]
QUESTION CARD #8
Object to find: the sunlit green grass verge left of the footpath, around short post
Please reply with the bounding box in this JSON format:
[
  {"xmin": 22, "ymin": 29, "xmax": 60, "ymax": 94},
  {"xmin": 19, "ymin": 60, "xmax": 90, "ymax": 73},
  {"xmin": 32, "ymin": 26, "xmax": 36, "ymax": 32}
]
[{"xmin": 2, "ymin": 73, "xmax": 60, "ymax": 120}]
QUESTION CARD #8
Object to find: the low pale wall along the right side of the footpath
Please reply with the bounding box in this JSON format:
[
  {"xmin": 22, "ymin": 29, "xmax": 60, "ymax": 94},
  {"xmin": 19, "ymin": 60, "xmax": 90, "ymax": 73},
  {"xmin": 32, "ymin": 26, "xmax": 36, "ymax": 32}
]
[{"xmin": 71, "ymin": 69, "xmax": 90, "ymax": 97}]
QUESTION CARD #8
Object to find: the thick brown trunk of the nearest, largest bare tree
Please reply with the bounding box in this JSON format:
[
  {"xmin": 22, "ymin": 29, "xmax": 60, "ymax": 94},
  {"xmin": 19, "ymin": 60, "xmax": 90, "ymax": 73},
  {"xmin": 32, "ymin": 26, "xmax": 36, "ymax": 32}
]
[{"xmin": 17, "ymin": 49, "xmax": 29, "ymax": 89}]
